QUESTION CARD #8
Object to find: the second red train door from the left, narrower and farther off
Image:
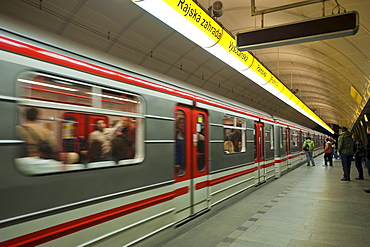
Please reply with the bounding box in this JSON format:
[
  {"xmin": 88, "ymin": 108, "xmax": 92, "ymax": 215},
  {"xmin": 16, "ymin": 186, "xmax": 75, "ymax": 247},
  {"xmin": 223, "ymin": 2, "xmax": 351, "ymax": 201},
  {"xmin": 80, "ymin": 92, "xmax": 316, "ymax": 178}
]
[{"xmin": 254, "ymin": 122, "xmax": 266, "ymax": 184}]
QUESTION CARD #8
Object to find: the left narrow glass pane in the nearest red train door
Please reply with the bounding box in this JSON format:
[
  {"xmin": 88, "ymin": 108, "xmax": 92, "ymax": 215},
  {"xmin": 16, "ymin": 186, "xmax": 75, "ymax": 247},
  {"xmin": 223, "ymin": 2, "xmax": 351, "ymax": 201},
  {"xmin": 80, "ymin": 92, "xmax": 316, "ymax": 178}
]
[{"xmin": 175, "ymin": 110, "xmax": 187, "ymax": 176}]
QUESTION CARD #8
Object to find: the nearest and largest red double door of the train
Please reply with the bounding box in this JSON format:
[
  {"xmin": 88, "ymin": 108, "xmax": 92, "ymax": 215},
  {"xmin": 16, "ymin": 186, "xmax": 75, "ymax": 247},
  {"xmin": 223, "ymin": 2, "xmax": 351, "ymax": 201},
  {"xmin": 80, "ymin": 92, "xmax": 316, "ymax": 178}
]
[{"xmin": 175, "ymin": 106, "xmax": 209, "ymax": 220}]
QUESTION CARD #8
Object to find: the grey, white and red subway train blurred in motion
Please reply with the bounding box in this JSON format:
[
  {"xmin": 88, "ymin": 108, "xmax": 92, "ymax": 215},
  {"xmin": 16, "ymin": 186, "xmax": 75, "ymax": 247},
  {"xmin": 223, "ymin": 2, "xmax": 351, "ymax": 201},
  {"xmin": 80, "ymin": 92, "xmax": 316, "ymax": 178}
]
[{"xmin": 0, "ymin": 16, "xmax": 325, "ymax": 247}]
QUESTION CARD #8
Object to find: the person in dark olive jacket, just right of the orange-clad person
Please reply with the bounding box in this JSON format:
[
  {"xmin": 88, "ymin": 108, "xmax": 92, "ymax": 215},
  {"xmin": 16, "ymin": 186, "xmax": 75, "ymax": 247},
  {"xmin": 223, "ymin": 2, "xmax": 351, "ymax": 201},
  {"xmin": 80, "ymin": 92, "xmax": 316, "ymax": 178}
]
[{"xmin": 338, "ymin": 127, "xmax": 353, "ymax": 181}]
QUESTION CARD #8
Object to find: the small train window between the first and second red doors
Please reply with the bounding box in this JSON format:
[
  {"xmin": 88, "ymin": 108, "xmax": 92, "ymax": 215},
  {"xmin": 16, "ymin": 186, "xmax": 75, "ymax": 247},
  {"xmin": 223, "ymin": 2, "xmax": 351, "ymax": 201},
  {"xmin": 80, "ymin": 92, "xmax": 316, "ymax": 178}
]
[{"xmin": 224, "ymin": 116, "xmax": 246, "ymax": 154}]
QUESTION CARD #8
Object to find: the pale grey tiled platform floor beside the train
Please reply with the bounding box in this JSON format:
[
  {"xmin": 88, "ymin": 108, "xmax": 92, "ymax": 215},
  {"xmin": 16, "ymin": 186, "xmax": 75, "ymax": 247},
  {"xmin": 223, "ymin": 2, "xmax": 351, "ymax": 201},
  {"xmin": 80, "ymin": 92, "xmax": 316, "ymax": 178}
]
[{"xmin": 163, "ymin": 155, "xmax": 370, "ymax": 247}]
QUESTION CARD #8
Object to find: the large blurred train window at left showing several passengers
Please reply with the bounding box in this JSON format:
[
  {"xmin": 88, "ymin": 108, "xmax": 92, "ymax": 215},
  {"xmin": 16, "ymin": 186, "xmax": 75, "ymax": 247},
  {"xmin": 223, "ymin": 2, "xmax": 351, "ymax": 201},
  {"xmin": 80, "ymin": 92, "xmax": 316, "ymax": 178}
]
[{"xmin": 16, "ymin": 72, "xmax": 144, "ymax": 174}]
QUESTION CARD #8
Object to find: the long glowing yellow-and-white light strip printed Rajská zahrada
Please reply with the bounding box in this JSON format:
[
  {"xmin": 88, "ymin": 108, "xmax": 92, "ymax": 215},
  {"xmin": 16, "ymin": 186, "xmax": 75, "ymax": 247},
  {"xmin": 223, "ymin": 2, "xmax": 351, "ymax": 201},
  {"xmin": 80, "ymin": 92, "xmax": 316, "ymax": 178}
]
[{"xmin": 132, "ymin": 0, "xmax": 334, "ymax": 133}]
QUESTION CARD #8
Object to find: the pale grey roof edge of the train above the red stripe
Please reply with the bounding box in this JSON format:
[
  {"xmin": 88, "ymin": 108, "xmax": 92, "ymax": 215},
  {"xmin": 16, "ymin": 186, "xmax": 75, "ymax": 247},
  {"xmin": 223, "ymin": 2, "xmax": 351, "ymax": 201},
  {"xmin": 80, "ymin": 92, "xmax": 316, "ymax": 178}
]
[{"xmin": 0, "ymin": 14, "xmax": 273, "ymax": 121}]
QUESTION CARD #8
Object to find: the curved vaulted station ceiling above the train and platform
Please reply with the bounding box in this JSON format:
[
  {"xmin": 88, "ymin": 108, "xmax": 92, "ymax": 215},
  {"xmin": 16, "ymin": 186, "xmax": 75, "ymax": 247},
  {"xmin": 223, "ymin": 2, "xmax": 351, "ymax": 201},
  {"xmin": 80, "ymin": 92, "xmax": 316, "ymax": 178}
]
[{"xmin": 0, "ymin": 0, "xmax": 370, "ymax": 133}]
